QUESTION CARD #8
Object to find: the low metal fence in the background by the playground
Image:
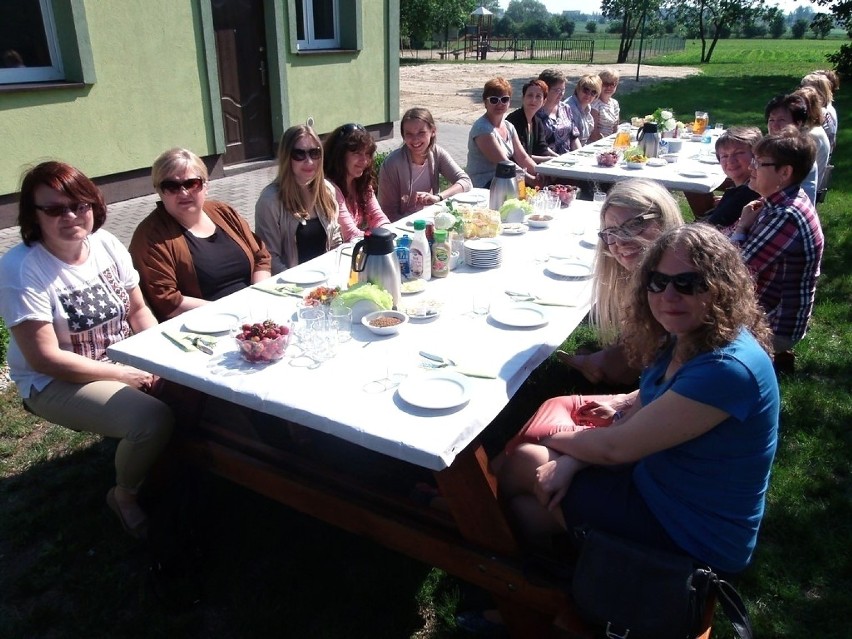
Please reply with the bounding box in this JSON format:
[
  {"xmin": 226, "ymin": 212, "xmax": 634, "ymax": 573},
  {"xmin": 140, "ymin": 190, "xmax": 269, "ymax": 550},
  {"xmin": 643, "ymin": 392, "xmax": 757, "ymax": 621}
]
[{"xmin": 399, "ymin": 35, "xmax": 685, "ymax": 64}]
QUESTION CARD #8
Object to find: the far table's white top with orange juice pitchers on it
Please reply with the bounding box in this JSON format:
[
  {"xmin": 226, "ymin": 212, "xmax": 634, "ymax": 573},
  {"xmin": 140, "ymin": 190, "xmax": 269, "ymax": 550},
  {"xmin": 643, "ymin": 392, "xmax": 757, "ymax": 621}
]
[{"xmin": 536, "ymin": 136, "xmax": 725, "ymax": 193}]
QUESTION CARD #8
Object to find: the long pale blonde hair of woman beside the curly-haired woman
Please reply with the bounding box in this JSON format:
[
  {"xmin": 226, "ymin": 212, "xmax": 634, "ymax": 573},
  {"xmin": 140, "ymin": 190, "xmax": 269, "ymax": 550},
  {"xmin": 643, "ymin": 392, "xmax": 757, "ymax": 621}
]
[{"xmin": 591, "ymin": 178, "xmax": 683, "ymax": 345}]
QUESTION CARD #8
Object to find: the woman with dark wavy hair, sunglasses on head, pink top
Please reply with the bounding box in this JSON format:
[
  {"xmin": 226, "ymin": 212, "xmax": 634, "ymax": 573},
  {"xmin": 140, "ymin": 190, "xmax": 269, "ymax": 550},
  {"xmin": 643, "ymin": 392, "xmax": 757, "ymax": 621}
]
[{"xmin": 323, "ymin": 124, "xmax": 390, "ymax": 242}]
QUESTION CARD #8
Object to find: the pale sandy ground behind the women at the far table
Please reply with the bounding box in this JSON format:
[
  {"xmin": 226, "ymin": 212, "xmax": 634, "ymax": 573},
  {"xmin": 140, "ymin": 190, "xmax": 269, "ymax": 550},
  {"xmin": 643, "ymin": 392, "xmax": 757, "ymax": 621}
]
[{"xmin": 399, "ymin": 63, "xmax": 700, "ymax": 125}]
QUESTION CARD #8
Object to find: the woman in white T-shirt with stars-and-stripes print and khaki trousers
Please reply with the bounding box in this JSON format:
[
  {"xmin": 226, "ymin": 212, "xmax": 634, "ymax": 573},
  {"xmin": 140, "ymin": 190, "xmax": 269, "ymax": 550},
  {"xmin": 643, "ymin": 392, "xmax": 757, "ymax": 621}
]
[{"xmin": 0, "ymin": 162, "xmax": 174, "ymax": 538}]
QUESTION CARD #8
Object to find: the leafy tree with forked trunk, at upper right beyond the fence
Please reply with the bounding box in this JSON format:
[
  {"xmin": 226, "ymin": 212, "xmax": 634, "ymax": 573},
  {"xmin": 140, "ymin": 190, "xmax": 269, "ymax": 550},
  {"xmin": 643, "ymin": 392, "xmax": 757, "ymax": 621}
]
[{"xmin": 667, "ymin": 0, "xmax": 763, "ymax": 64}]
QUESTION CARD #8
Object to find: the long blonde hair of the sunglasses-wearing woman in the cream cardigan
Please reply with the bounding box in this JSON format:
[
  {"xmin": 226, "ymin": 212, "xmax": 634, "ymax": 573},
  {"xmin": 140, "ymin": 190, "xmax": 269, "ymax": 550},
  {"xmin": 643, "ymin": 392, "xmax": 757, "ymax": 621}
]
[{"xmin": 274, "ymin": 124, "xmax": 337, "ymax": 220}]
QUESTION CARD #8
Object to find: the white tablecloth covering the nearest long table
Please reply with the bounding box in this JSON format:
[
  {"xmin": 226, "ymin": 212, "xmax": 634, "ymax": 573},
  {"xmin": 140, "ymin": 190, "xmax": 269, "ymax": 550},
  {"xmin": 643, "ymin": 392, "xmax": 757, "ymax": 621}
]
[{"xmin": 109, "ymin": 201, "xmax": 599, "ymax": 470}]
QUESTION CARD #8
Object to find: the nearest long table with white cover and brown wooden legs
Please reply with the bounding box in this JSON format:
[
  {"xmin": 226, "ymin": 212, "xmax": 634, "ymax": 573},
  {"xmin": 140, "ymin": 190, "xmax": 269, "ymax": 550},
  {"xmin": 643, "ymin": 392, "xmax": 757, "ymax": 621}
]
[{"xmin": 109, "ymin": 196, "xmax": 599, "ymax": 637}]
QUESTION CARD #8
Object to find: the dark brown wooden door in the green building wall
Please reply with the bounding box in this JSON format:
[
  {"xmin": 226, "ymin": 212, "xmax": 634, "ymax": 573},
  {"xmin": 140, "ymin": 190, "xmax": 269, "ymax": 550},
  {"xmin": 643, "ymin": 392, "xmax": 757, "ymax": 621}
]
[{"xmin": 212, "ymin": 0, "xmax": 273, "ymax": 165}]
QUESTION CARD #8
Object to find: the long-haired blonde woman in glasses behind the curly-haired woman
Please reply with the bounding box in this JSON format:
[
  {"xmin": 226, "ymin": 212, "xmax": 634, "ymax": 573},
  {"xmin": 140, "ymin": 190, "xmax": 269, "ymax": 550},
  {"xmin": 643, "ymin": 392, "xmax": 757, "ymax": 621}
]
[{"xmin": 556, "ymin": 178, "xmax": 683, "ymax": 385}]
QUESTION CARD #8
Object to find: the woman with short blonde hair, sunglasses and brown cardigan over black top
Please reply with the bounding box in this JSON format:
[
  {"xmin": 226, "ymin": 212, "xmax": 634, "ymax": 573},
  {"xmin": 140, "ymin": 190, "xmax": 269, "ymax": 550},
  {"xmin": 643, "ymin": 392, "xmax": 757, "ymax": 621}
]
[{"xmin": 130, "ymin": 148, "xmax": 270, "ymax": 321}]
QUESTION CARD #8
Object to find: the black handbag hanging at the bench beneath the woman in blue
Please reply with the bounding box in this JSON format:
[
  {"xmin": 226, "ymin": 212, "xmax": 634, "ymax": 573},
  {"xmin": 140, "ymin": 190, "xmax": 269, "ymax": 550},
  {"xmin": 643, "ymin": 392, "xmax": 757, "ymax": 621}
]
[{"xmin": 572, "ymin": 529, "xmax": 752, "ymax": 639}]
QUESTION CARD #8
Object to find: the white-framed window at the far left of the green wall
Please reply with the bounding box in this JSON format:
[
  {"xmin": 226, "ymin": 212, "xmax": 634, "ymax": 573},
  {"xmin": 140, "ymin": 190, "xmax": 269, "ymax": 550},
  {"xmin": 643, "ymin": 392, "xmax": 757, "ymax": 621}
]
[{"xmin": 0, "ymin": 0, "xmax": 65, "ymax": 84}]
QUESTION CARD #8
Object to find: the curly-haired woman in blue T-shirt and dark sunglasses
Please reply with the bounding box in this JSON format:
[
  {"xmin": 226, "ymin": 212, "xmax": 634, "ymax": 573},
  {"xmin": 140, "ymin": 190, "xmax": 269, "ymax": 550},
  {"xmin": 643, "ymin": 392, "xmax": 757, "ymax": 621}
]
[{"xmin": 500, "ymin": 224, "xmax": 779, "ymax": 573}]
